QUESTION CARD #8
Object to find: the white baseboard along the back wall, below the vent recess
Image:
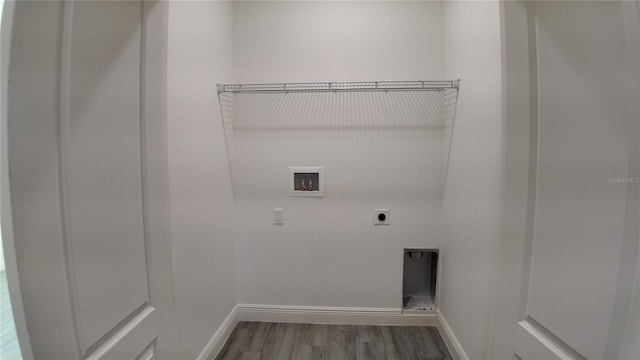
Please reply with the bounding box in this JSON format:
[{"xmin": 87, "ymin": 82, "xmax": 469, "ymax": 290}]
[{"xmin": 236, "ymin": 304, "xmax": 438, "ymax": 326}]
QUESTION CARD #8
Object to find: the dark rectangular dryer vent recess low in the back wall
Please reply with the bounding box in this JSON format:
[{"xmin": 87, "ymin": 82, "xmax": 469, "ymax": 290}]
[{"xmin": 402, "ymin": 249, "xmax": 438, "ymax": 312}]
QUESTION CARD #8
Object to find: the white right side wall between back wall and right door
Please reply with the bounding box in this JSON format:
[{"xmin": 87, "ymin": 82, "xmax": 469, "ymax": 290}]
[{"xmin": 440, "ymin": 1, "xmax": 501, "ymax": 359}]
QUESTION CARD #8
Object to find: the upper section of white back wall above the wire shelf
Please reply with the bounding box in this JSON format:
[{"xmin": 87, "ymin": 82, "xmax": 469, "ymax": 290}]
[{"xmin": 234, "ymin": 1, "xmax": 443, "ymax": 83}]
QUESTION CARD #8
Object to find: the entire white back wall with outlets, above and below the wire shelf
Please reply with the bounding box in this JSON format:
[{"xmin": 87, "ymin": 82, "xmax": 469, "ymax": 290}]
[{"xmin": 234, "ymin": 2, "xmax": 443, "ymax": 308}]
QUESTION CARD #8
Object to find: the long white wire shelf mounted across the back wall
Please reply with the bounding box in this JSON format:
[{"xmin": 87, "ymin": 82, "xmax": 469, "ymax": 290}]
[{"xmin": 218, "ymin": 80, "xmax": 460, "ymax": 94}]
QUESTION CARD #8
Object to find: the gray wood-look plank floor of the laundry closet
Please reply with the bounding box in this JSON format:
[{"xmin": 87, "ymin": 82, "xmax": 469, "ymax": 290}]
[{"xmin": 216, "ymin": 322, "xmax": 452, "ymax": 360}]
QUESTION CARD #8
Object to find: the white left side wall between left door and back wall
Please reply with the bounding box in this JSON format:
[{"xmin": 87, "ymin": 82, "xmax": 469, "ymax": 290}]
[{"xmin": 167, "ymin": 1, "xmax": 236, "ymax": 359}]
